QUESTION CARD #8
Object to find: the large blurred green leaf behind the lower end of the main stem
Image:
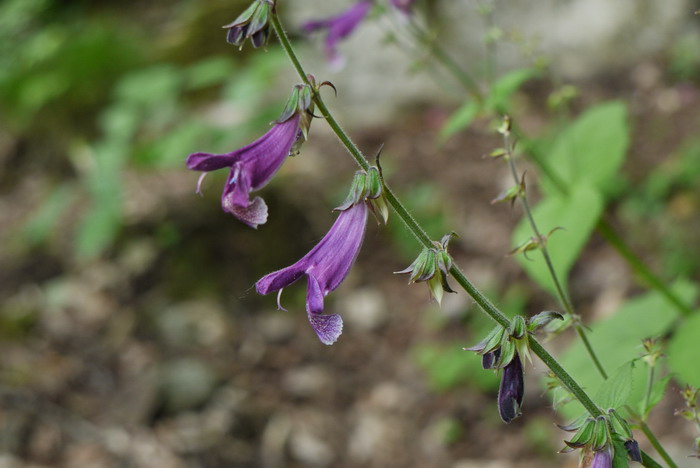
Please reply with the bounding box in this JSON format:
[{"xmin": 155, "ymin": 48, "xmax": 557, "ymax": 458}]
[{"xmin": 553, "ymin": 281, "xmax": 699, "ymax": 419}]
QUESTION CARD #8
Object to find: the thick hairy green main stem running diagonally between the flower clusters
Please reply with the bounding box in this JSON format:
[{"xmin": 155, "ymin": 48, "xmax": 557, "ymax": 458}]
[{"xmin": 270, "ymin": 14, "xmax": 656, "ymax": 467}]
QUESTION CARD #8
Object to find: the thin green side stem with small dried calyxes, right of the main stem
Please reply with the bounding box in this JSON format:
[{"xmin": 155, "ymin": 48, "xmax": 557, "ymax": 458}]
[{"xmin": 503, "ymin": 131, "xmax": 608, "ymax": 380}]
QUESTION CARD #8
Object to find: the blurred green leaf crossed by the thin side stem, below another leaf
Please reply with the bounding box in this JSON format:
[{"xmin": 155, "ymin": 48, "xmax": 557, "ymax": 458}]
[{"xmin": 513, "ymin": 184, "xmax": 603, "ymax": 293}]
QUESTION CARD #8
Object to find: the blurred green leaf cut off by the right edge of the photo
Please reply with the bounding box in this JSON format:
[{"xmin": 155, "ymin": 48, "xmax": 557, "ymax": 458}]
[{"xmin": 667, "ymin": 313, "xmax": 700, "ymax": 387}]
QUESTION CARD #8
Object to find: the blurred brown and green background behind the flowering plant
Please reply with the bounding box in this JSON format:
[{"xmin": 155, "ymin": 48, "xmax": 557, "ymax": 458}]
[{"xmin": 0, "ymin": 0, "xmax": 700, "ymax": 468}]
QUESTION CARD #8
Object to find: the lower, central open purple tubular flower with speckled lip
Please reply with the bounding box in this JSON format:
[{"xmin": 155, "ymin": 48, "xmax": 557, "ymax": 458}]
[{"xmin": 255, "ymin": 202, "xmax": 367, "ymax": 345}]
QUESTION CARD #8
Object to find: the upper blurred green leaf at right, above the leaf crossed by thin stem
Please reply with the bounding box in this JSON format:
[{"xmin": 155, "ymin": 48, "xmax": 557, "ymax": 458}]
[{"xmin": 542, "ymin": 101, "xmax": 629, "ymax": 197}]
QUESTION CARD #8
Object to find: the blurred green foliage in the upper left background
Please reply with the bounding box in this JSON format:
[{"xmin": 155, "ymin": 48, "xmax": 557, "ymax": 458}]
[{"xmin": 0, "ymin": 0, "xmax": 284, "ymax": 258}]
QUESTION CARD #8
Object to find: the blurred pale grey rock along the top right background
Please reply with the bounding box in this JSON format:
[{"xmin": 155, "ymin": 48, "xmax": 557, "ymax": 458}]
[{"xmin": 286, "ymin": 0, "xmax": 694, "ymax": 127}]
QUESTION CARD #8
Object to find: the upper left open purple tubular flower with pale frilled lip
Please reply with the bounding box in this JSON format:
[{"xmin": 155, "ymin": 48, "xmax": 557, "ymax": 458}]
[{"xmin": 187, "ymin": 114, "xmax": 301, "ymax": 228}]
